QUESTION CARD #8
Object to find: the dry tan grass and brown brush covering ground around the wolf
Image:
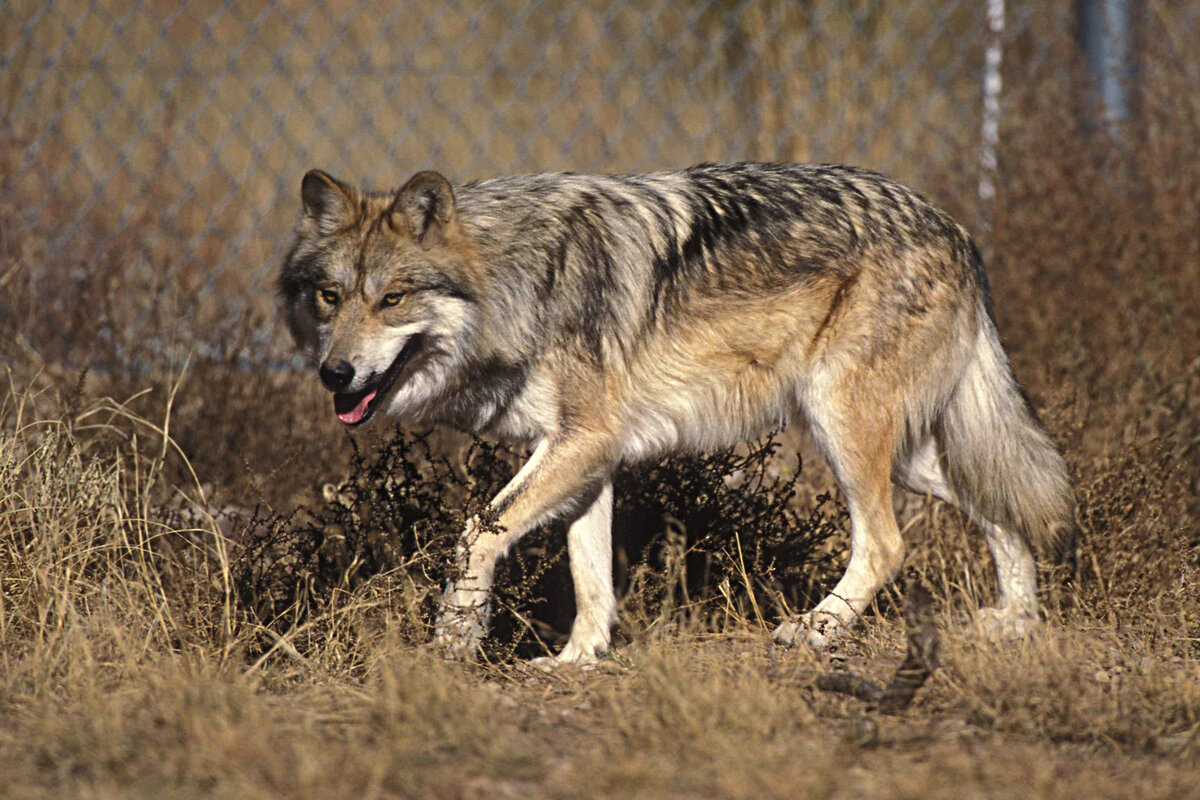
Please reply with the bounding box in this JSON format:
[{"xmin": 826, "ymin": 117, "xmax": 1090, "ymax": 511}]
[{"xmin": 0, "ymin": 17, "xmax": 1200, "ymax": 799}]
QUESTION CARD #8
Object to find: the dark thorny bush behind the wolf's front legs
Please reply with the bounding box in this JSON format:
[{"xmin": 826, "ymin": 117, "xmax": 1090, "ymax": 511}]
[{"xmin": 234, "ymin": 431, "xmax": 845, "ymax": 660}]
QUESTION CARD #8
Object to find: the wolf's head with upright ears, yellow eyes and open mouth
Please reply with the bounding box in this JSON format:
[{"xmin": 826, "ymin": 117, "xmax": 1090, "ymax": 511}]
[{"xmin": 278, "ymin": 170, "xmax": 479, "ymax": 425}]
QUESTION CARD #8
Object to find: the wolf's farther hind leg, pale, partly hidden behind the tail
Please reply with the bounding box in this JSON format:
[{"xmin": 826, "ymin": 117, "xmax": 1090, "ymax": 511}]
[{"xmin": 895, "ymin": 435, "xmax": 1038, "ymax": 640}]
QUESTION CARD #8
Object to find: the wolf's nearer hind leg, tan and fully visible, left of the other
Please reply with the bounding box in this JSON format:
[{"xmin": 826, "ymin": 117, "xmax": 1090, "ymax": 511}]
[{"xmin": 774, "ymin": 380, "xmax": 904, "ymax": 646}]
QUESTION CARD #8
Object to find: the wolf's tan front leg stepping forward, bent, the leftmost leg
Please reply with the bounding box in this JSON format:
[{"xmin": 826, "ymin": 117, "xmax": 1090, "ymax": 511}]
[{"xmin": 434, "ymin": 433, "xmax": 614, "ymax": 658}]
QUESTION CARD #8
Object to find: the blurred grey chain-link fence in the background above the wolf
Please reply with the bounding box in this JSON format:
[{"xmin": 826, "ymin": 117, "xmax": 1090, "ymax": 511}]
[{"xmin": 0, "ymin": 0, "xmax": 1200, "ymax": 364}]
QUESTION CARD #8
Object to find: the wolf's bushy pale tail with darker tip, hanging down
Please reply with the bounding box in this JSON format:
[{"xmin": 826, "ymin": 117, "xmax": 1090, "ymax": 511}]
[{"xmin": 938, "ymin": 313, "xmax": 1075, "ymax": 559}]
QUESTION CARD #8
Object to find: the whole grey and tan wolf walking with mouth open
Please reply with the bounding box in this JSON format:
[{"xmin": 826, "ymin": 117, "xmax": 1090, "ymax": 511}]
[{"xmin": 277, "ymin": 163, "xmax": 1074, "ymax": 663}]
